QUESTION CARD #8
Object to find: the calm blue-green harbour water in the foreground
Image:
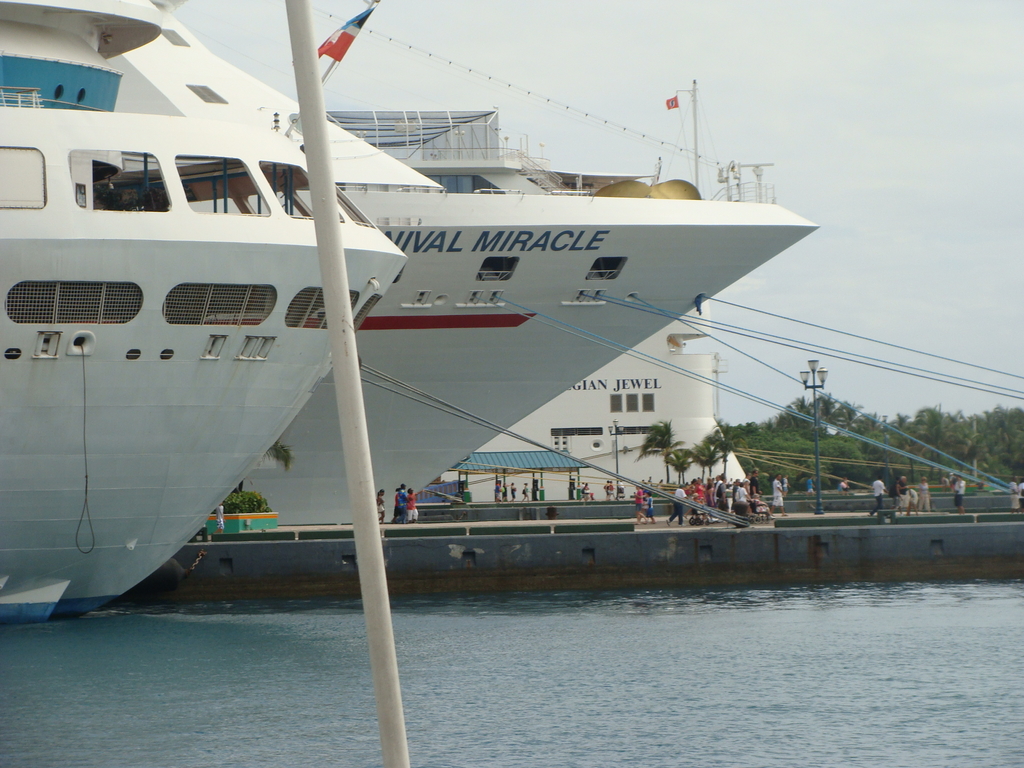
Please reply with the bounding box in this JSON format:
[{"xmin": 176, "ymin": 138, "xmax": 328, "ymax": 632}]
[{"xmin": 0, "ymin": 582, "xmax": 1024, "ymax": 768}]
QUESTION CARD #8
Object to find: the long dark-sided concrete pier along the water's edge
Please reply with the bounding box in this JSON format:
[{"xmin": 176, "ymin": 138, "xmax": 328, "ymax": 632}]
[{"xmin": 148, "ymin": 514, "xmax": 1024, "ymax": 601}]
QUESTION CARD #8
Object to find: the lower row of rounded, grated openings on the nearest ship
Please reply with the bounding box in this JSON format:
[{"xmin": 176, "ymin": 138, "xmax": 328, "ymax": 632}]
[{"xmin": 6, "ymin": 281, "xmax": 372, "ymax": 328}]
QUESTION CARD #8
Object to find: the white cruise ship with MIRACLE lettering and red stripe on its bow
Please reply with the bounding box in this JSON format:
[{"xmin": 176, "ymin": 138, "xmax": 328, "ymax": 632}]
[{"xmin": 119, "ymin": 13, "xmax": 815, "ymax": 522}]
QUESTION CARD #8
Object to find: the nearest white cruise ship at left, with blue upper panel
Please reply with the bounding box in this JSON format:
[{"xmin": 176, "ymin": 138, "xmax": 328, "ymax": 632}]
[{"xmin": 0, "ymin": 0, "xmax": 406, "ymax": 622}]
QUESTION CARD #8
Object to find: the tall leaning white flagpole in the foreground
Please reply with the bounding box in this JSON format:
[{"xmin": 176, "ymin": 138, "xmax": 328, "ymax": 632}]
[{"xmin": 286, "ymin": 0, "xmax": 409, "ymax": 768}]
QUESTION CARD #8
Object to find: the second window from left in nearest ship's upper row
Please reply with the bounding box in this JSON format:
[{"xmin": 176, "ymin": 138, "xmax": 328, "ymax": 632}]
[{"xmin": 69, "ymin": 150, "xmax": 171, "ymax": 213}]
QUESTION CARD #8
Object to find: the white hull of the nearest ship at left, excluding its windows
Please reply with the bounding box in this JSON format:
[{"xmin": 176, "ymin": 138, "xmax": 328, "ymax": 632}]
[{"xmin": 0, "ymin": 109, "xmax": 403, "ymax": 621}]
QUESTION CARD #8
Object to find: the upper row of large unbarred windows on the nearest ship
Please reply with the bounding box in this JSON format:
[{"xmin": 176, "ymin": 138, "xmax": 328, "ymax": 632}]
[{"xmin": 0, "ymin": 146, "xmax": 372, "ymax": 226}]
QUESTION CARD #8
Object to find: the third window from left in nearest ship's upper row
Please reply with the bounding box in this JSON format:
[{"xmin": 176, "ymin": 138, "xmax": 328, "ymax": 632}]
[{"xmin": 175, "ymin": 155, "xmax": 270, "ymax": 216}]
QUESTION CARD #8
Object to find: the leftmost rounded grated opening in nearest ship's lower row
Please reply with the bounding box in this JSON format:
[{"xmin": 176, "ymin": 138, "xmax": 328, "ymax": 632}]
[{"xmin": 7, "ymin": 281, "xmax": 142, "ymax": 325}]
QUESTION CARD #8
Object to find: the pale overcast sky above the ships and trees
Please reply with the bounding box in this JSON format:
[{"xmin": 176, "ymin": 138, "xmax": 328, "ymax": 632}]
[{"xmin": 178, "ymin": 0, "xmax": 1024, "ymax": 423}]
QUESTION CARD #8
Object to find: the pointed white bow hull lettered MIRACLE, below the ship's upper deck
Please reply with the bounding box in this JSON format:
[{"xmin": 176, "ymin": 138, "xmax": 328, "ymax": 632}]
[{"xmin": 250, "ymin": 193, "xmax": 814, "ymax": 523}]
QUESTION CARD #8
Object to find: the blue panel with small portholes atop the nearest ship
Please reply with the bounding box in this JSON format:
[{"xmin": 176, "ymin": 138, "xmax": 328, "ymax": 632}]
[{"xmin": 0, "ymin": 54, "xmax": 121, "ymax": 112}]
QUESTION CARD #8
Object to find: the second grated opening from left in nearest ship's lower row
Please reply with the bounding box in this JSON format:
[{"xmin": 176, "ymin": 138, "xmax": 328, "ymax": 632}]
[{"xmin": 164, "ymin": 283, "xmax": 278, "ymax": 326}]
